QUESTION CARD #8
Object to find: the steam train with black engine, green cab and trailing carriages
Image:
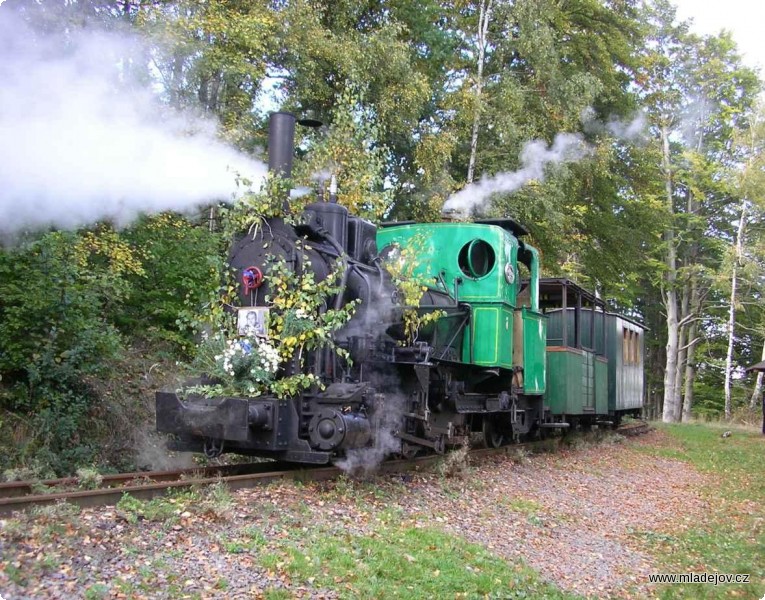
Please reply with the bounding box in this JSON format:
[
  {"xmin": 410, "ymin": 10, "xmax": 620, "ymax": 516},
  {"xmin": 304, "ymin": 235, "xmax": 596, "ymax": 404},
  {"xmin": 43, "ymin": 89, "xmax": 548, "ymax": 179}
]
[{"xmin": 156, "ymin": 113, "xmax": 644, "ymax": 464}]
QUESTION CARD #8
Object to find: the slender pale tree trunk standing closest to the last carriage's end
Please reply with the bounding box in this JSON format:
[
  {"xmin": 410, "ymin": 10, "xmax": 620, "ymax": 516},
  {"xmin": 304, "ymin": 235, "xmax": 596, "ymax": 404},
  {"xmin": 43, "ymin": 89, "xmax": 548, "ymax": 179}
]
[{"xmin": 661, "ymin": 124, "xmax": 679, "ymax": 423}]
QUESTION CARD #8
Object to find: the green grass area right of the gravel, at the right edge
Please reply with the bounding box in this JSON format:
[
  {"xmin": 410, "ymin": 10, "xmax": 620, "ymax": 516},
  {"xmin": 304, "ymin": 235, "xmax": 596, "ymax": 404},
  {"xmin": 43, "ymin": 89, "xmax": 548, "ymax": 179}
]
[{"xmin": 639, "ymin": 424, "xmax": 765, "ymax": 600}]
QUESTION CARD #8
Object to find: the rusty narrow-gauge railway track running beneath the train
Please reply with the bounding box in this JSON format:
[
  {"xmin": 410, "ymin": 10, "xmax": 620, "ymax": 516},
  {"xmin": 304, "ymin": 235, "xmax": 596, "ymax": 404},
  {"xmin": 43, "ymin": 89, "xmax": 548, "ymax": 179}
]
[{"xmin": 0, "ymin": 422, "xmax": 650, "ymax": 515}]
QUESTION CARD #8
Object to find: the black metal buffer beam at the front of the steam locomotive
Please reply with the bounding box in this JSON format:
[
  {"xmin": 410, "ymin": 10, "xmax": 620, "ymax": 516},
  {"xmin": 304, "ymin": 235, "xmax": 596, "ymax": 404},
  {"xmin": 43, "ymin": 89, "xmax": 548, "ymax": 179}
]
[{"xmin": 156, "ymin": 392, "xmax": 275, "ymax": 442}]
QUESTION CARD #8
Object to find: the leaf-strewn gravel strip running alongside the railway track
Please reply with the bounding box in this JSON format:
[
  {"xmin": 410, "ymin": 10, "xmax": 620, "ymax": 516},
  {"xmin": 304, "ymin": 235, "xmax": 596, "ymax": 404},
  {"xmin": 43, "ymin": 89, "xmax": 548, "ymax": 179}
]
[{"xmin": 0, "ymin": 432, "xmax": 707, "ymax": 600}]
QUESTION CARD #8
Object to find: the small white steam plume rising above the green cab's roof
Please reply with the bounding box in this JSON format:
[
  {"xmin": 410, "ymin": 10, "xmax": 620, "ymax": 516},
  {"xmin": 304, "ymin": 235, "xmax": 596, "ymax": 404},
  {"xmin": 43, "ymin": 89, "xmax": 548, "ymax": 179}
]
[{"xmin": 443, "ymin": 133, "xmax": 590, "ymax": 216}]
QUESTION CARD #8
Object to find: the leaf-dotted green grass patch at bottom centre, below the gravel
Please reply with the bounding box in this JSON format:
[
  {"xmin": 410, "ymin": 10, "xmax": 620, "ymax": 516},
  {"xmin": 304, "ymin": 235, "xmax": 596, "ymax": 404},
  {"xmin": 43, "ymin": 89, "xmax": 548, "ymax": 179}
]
[{"xmin": 261, "ymin": 525, "xmax": 574, "ymax": 599}]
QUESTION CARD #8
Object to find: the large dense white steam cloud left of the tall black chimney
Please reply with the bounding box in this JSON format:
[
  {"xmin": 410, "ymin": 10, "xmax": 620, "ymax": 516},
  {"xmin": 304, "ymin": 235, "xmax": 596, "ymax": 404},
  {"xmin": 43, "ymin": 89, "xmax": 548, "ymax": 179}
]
[{"xmin": 0, "ymin": 13, "xmax": 266, "ymax": 234}]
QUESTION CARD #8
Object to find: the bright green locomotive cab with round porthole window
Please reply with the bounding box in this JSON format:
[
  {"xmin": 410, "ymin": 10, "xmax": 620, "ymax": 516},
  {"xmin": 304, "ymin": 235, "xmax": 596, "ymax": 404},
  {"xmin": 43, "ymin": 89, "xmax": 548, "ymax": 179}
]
[{"xmin": 377, "ymin": 219, "xmax": 546, "ymax": 394}]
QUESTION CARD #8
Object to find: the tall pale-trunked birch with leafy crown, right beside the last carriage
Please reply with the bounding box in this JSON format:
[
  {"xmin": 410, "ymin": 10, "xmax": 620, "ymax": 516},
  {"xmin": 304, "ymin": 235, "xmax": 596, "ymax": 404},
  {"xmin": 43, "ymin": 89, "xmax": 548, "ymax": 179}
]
[{"xmin": 637, "ymin": 0, "xmax": 758, "ymax": 422}]
